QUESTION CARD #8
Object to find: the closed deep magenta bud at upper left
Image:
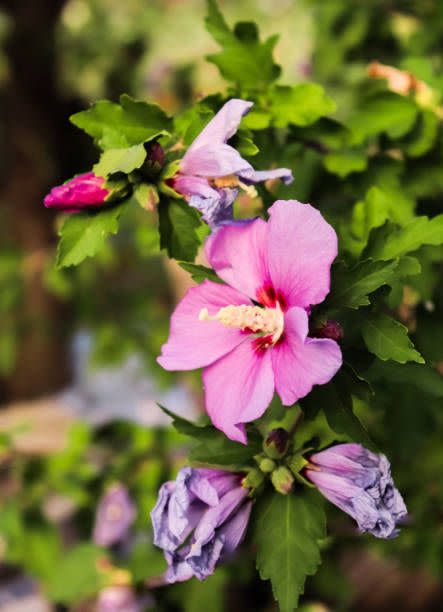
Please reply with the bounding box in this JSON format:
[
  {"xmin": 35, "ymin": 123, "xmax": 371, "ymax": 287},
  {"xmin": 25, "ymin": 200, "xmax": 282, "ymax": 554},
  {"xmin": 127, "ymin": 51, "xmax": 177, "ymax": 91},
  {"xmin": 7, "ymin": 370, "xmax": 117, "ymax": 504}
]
[{"xmin": 44, "ymin": 172, "xmax": 110, "ymax": 212}]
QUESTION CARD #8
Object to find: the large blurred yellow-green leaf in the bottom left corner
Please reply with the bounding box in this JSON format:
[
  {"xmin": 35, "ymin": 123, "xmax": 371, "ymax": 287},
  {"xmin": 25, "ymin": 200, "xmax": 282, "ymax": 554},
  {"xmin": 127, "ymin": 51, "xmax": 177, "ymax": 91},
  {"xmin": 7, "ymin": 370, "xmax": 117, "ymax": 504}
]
[{"xmin": 48, "ymin": 544, "xmax": 105, "ymax": 604}]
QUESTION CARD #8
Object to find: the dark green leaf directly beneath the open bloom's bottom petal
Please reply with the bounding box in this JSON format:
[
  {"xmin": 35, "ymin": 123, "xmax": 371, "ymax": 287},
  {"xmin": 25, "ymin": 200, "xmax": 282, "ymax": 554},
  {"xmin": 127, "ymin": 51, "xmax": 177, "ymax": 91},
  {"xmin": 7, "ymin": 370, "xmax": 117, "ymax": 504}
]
[{"xmin": 160, "ymin": 406, "xmax": 262, "ymax": 469}]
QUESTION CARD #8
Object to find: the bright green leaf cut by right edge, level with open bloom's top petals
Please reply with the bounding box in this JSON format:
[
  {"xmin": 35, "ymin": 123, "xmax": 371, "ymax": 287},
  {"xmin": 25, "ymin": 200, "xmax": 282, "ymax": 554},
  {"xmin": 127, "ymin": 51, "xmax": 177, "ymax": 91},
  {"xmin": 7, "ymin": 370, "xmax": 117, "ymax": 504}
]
[{"xmin": 364, "ymin": 214, "xmax": 443, "ymax": 260}]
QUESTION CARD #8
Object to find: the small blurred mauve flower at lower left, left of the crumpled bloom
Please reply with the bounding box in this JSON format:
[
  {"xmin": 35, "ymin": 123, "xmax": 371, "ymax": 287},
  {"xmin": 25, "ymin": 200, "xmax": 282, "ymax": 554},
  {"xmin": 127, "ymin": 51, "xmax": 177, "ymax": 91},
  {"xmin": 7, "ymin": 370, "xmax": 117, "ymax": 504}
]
[{"xmin": 93, "ymin": 484, "xmax": 136, "ymax": 546}]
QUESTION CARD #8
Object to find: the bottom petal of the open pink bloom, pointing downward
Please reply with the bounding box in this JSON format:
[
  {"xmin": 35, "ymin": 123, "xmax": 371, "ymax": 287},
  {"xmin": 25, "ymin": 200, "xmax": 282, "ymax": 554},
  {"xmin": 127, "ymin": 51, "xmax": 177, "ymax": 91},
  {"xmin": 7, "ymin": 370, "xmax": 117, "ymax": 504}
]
[{"xmin": 203, "ymin": 339, "xmax": 274, "ymax": 444}]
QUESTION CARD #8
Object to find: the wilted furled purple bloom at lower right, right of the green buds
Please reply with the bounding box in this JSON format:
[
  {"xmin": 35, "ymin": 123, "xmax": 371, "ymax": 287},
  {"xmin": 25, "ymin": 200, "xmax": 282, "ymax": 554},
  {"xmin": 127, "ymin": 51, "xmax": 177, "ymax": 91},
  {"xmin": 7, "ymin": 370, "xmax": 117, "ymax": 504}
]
[{"xmin": 304, "ymin": 444, "xmax": 407, "ymax": 538}]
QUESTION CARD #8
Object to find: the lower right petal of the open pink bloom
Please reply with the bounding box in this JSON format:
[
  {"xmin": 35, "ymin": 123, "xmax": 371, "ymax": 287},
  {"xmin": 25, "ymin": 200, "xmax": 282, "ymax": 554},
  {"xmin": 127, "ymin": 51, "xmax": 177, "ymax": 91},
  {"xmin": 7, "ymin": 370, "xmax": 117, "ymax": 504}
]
[{"xmin": 272, "ymin": 307, "xmax": 342, "ymax": 406}]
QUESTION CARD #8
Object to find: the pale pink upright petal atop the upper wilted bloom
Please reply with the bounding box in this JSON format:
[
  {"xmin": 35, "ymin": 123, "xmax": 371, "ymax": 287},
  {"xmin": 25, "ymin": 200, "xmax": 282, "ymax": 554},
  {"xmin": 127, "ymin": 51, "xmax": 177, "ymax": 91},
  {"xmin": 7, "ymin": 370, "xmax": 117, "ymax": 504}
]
[{"xmin": 185, "ymin": 98, "xmax": 253, "ymax": 153}]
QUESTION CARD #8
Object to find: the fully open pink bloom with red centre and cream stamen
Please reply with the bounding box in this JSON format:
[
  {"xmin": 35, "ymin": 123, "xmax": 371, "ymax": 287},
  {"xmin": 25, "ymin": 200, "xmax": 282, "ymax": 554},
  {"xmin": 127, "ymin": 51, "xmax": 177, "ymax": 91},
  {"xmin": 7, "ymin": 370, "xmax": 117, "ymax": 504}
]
[{"xmin": 158, "ymin": 200, "xmax": 342, "ymax": 443}]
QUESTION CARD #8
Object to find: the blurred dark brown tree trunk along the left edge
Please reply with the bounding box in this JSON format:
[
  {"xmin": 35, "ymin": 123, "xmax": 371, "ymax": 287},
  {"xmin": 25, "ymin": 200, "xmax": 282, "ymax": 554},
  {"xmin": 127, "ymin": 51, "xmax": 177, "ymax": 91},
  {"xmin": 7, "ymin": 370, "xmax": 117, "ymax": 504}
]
[{"xmin": 0, "ymin": 0, "xmax": 89, "ymax": 400}]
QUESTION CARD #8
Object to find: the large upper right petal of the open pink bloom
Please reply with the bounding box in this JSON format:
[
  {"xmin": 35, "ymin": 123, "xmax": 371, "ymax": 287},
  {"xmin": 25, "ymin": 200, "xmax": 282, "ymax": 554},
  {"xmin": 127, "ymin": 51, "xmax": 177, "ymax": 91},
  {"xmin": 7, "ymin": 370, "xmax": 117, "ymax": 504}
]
[{"xmin": 268, "ymin": 200, "xmax": 337, "ymax": 307}]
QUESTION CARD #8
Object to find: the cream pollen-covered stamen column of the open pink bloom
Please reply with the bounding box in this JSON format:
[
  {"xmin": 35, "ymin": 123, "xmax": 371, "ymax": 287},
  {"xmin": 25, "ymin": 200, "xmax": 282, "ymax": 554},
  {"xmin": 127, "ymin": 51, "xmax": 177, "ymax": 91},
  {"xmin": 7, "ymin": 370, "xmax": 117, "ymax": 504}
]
[{"xmin": 198, "ymin": 303, "xmax": 284, "ymax": 344}]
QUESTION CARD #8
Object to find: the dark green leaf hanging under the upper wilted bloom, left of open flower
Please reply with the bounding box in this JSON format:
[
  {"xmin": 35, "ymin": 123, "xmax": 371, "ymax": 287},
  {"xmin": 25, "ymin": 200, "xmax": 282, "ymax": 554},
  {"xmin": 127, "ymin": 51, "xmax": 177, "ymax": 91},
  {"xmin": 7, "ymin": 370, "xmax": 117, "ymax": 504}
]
[{"xmin": 158, "ymin": 198, "xmax": 200, "ymax": 261}]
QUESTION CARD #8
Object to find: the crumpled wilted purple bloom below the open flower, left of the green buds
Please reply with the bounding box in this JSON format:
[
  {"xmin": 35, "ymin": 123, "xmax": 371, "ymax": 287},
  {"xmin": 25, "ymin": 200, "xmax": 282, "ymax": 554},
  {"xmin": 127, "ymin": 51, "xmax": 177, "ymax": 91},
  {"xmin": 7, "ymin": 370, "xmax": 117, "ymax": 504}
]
[{"xmin": 151, "ymin": 467, "xmax": 252, "ymax": 583}]
